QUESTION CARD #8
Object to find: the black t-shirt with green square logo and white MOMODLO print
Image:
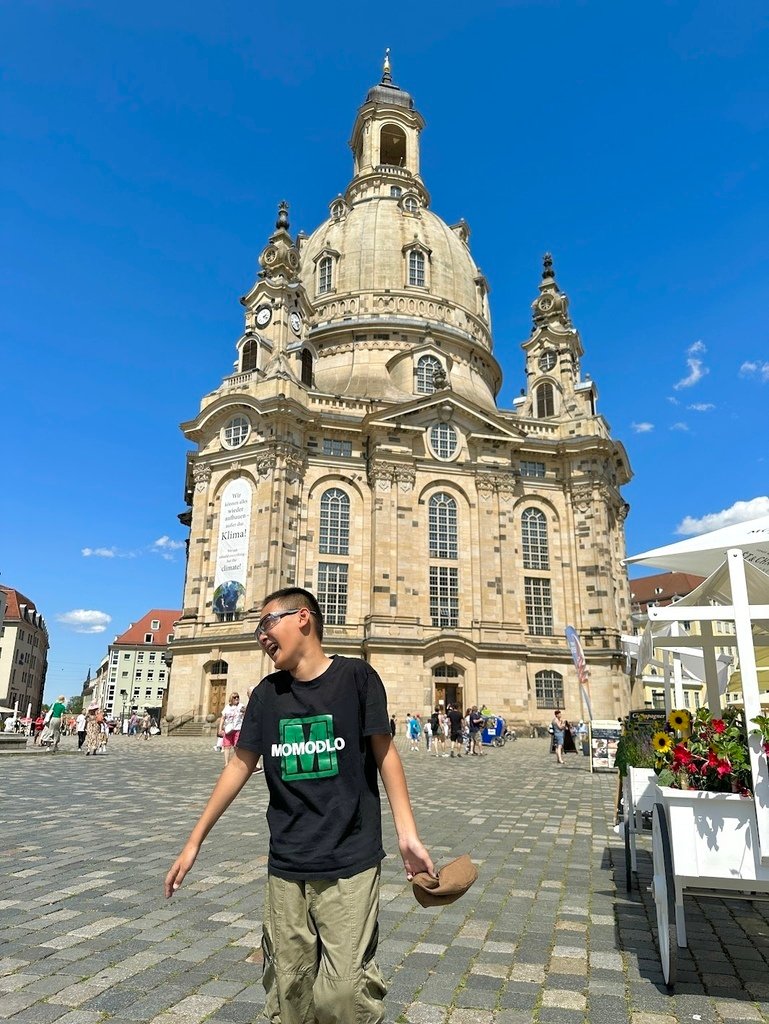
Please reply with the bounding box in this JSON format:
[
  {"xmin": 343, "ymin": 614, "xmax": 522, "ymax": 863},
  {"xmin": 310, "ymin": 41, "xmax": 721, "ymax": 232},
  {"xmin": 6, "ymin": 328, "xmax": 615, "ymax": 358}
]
[{"xmin": 238, "ymin": 656, "xmax": 390, "ymax": 880}]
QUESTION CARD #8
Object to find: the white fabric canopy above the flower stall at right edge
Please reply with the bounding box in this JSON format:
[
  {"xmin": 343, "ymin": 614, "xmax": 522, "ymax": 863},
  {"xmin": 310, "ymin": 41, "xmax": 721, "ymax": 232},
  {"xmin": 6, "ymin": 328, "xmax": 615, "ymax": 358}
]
[{"xmin": 625, "ymin": 515, "xmax": 769, "ymax": 575}]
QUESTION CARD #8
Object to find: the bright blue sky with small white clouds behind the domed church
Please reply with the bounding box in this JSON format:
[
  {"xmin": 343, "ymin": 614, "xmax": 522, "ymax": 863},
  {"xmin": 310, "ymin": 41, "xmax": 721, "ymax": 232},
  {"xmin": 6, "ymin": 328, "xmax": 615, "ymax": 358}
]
[{"xmin": 0, "ymin": 0, "xmax": 769, "ymax": 697}]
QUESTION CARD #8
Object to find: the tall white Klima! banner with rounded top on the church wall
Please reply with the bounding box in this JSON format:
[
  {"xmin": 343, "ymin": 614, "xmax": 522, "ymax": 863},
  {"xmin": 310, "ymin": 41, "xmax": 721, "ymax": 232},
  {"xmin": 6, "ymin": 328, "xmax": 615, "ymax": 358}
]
[{"xmin": 213, "ymin": 479, "xmax": 251, "ymax": 615}]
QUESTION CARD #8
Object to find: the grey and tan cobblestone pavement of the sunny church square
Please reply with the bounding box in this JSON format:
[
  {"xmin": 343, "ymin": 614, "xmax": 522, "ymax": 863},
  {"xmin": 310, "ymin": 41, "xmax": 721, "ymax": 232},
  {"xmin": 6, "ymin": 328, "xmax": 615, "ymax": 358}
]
[{"xmin": 0, "ymin": 737, "xmax": 769, "ymax": 1024}]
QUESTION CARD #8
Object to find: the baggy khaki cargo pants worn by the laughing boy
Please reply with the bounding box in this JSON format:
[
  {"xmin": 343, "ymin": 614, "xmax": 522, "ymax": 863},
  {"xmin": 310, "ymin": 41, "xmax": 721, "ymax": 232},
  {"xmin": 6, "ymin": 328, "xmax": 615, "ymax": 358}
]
[{"xmin": 262, "ymin": 865, "xmax": 387, "ymax": 1024}]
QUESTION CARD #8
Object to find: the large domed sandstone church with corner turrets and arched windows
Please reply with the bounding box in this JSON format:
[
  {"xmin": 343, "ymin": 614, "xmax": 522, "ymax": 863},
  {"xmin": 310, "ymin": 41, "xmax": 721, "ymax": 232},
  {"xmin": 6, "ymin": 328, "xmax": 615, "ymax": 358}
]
[{"xmin": 167, "ymin": 60, "xmax": 631, "ymax": 726}]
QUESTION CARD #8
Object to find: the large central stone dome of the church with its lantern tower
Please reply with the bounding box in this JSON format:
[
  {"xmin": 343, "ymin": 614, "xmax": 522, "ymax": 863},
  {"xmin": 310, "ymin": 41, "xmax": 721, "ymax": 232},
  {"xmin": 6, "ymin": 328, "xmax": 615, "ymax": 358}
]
[{"xmin": 298, "ymin": 59, "xmax": 502, "ymax": 407}]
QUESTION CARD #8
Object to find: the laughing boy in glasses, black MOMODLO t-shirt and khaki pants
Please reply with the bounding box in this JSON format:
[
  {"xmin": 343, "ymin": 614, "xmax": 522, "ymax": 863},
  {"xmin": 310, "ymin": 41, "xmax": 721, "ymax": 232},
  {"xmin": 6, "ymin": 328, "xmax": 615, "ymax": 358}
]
[{"xmin": 165, "ymin": 587, "xmax": 435, "ymax": 1024}]
